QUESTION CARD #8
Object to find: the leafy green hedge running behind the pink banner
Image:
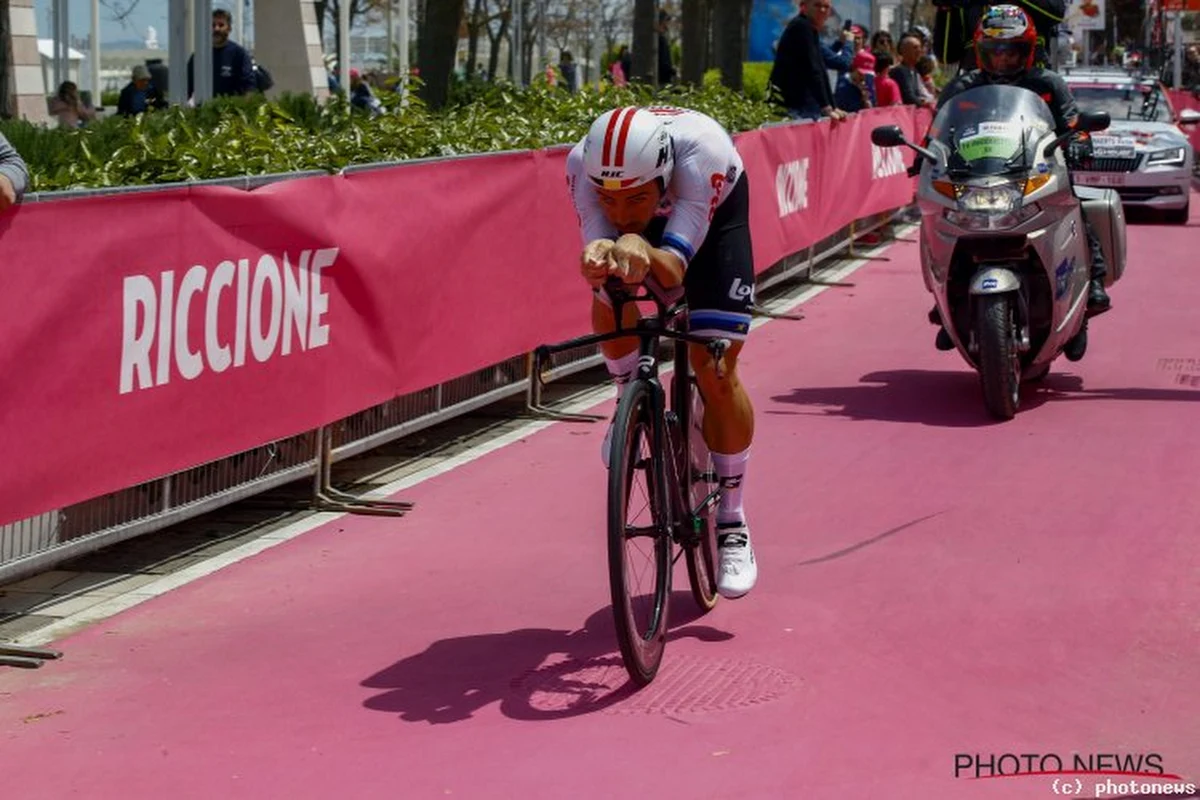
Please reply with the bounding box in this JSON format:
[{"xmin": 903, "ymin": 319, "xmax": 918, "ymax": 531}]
[{"xmin": 7, "ymin": 84, "xmax": 782, "ymax": 192}]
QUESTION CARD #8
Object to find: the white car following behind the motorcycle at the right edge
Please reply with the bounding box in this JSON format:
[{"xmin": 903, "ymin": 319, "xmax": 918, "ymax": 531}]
[{"xmin": 1063, "ymin": 70, "xmax": 1200, "ymax": 224}]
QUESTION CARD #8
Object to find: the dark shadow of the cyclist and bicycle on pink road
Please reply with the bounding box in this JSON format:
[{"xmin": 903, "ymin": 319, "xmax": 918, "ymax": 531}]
[{"xmin": 361, "ymin": 591, "xmax": 733, "ymax": 724}]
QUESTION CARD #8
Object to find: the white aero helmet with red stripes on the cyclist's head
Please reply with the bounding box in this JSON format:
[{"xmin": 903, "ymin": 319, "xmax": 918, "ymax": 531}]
[{"xmin": 583, "ymin": 107, "xmax": 674, "ymax": 190}]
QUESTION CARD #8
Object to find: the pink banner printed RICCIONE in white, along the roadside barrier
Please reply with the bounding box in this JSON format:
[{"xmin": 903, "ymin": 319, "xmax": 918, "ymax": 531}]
[{"xmin": 0, "ymin": 109, "xmax": 914, "ymax": 532}]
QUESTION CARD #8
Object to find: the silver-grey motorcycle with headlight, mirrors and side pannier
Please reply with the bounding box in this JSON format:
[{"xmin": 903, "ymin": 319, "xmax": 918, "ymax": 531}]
[{"xmin": 871, "ymin": 85, "xmax": 1126, "ymax": 420}]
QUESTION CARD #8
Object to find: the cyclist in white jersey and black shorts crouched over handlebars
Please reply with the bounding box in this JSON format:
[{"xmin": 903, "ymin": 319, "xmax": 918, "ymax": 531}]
[{"xmin": 566, "ymin": 107, "xmax": 758, "ymax": 599}]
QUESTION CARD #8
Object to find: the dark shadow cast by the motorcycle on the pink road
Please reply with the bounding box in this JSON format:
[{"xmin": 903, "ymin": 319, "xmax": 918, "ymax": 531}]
[{"xmin": 766, "ymin": 369, "xmax": 1200, "ymax": 428}]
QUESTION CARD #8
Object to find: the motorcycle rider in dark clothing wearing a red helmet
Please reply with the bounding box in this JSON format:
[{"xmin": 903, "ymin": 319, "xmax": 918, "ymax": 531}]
[{"xmin": 929, "ymin": 5, "xmax": 1111, "ymax": 350}]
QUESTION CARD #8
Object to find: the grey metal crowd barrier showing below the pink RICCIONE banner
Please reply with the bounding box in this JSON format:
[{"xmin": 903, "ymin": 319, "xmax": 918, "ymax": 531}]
[{"xmin": 0, "ymin": 159, "xmax": 896, "ymax": 584}]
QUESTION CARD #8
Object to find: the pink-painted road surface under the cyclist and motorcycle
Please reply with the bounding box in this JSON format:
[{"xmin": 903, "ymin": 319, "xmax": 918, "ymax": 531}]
[{"xmin": 0, "ymin": 198, "xmax": 1200, "ymax": 800}]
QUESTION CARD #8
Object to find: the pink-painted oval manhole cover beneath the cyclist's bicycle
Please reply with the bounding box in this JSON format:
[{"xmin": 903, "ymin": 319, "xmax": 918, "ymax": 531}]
[{"xmin": 511, "ymin": 648, "xmax": 799, "ymax": 716}]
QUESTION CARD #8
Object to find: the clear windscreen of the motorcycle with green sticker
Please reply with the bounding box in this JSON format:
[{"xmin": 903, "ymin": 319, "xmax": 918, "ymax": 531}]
[{"xmin": 930, "ymin": 85, "xmax": 1054, "ymax": 176}]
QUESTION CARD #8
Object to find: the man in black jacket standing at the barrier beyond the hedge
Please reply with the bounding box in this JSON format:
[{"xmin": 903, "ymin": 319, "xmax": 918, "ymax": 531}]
[{"xmin": 770, "ymin": 0, "xmax": 846, "ymax": 121}]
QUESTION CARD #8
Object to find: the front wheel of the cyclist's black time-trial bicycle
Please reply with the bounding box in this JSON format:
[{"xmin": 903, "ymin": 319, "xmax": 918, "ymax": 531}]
[{"xmin": 608, "ymin": 380, "xmax": 672, "ymax": 686}]
